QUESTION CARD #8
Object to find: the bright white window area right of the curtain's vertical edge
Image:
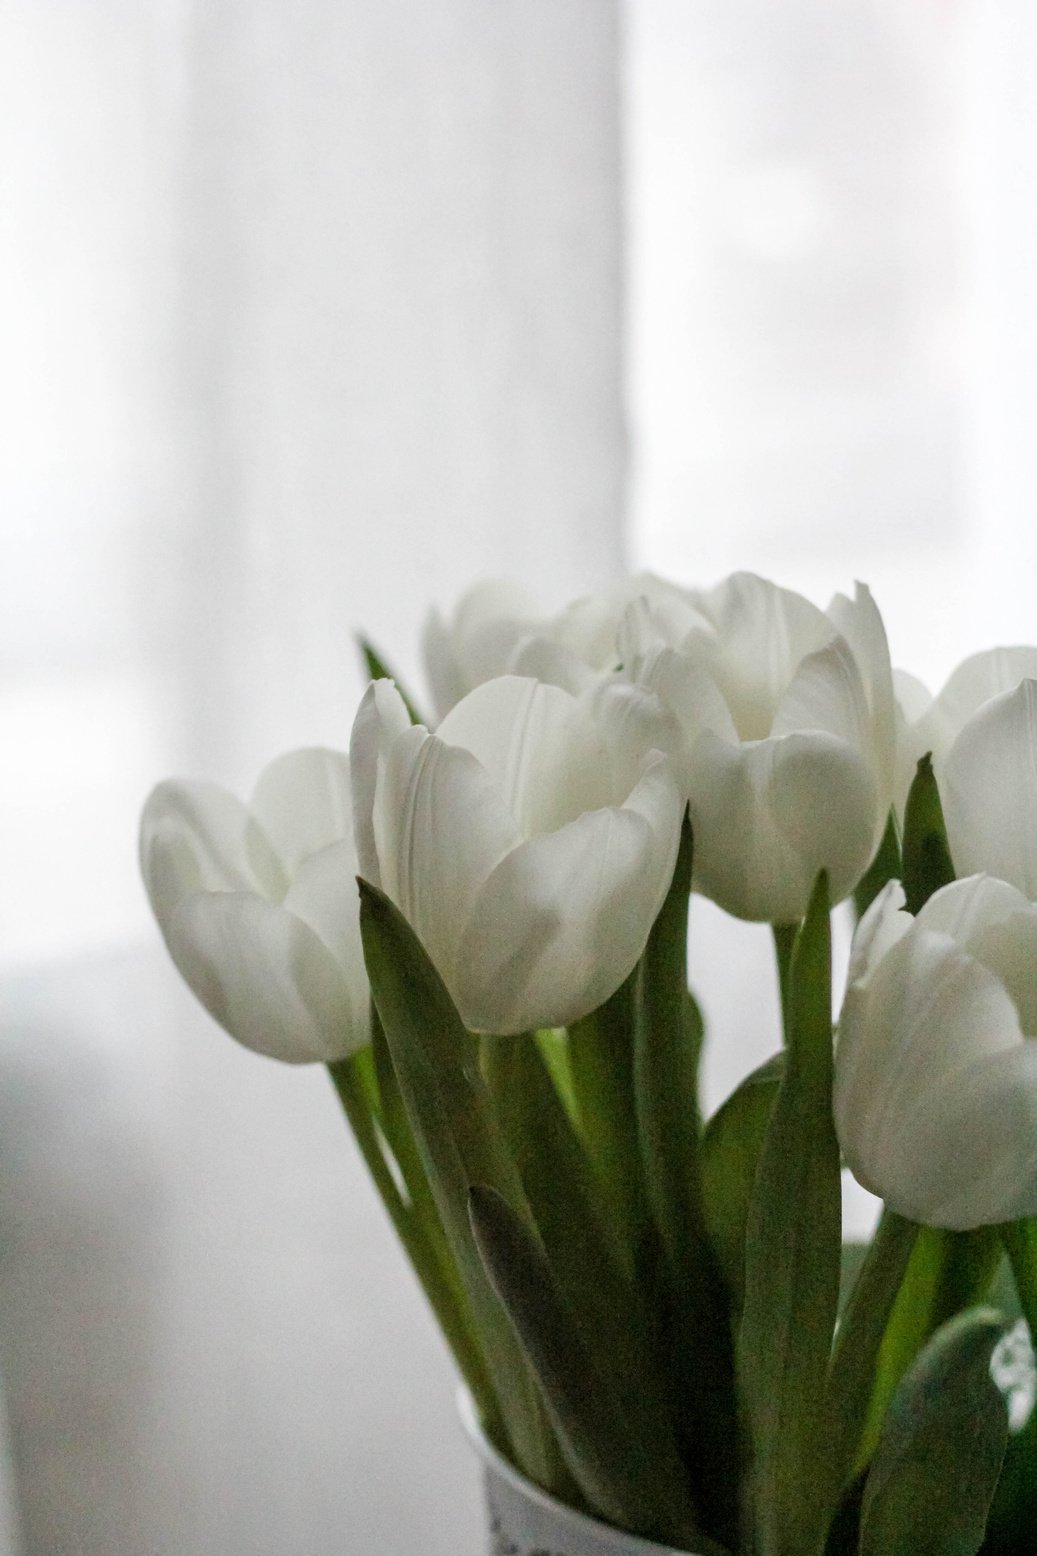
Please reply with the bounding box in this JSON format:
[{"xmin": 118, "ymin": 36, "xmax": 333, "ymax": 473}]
[{"xmin": 626, "ymin": 0, "xmax": 1037, "ymax": 1132}]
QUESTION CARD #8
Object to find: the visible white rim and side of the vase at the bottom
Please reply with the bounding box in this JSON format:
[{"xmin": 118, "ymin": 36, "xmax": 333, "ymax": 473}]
[{"xmin": 458, "ymin": 1391, "xmax": 694, "ymax": 1556}]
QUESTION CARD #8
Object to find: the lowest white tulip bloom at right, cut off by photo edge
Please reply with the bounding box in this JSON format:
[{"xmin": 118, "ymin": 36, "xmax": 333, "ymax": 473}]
[{"xmin": 833, "ymin": 876, "xmax": 1037, "ymax": 1231}]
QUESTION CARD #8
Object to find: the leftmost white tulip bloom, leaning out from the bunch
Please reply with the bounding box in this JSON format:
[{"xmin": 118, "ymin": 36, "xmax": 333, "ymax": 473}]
[{"xmin": 140, "ymin": 750, "xmax": 371, "ymax": 1063}]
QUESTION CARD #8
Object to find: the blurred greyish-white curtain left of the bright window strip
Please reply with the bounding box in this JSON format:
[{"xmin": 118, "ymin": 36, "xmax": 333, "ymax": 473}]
[{"xmin": 0, "ymin": 0, "xmax": 624, "ymax": 1556}]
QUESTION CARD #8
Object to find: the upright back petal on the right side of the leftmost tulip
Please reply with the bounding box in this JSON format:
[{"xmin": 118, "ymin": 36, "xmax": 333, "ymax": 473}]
[{"xmin": 251, "ymin": 747, "xmax": 355, "ymax": 874}]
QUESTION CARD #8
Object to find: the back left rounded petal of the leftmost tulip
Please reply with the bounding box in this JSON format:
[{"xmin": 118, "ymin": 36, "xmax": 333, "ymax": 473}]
[{"xmin": 140, "ymin": 778, "xmax": 286, "ymax": 934}]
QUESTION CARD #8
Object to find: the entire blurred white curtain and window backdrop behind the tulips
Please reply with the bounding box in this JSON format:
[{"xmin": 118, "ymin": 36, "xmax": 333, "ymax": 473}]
[{"xmin": 0, "ymin": 0, "xmax": 1037, "ymax": 1556}]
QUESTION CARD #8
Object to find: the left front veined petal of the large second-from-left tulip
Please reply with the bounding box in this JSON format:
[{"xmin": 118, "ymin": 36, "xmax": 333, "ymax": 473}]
[{"xmin": 374, "ymin": 721, "xmax": 520, "ymax": 983}]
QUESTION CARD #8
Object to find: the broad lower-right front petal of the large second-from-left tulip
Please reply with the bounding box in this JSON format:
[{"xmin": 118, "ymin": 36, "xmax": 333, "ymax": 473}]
[{"xmin": 455, "ymin": 758, "xmax": 680, "ymax": 1033}]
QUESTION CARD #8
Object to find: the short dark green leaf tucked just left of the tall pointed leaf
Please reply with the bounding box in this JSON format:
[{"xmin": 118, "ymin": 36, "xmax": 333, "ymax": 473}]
[{"xmin": 699, "ymin": 1053, "xmax": 785, "ymax": 1319}]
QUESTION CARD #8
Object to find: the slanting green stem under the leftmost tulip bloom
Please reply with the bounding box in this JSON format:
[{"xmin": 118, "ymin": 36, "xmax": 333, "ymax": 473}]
[{"xmin": 327, "ymin": 1055, "xmax": 500, "ymax": 1436}]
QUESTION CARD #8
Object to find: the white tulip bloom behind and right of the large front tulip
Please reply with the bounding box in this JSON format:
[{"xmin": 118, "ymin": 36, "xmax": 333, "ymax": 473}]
[{"xmin": 620, "ymin": 573, "xmax": 895, "ymax": 924}]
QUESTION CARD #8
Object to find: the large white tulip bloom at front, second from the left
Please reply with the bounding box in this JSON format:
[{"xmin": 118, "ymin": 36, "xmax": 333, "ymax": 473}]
[{"xmin": 350, "ymin": 675, "xmax": 682, "ymax": 1033}]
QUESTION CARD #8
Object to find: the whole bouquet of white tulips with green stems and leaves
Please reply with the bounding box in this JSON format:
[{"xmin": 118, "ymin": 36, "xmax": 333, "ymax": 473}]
[{"xmin": 142, "ymin": 574, "xmax": 1037, "ymax": 1556}]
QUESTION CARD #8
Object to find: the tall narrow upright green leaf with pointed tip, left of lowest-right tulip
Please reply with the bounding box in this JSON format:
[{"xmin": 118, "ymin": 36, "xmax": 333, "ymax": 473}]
[{"xmin": 738, "ymin": 873, "xmax": 842, "ymax": 1556}]
